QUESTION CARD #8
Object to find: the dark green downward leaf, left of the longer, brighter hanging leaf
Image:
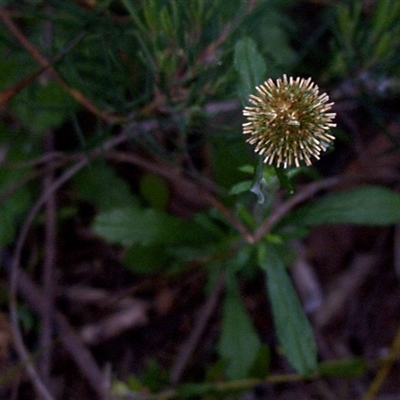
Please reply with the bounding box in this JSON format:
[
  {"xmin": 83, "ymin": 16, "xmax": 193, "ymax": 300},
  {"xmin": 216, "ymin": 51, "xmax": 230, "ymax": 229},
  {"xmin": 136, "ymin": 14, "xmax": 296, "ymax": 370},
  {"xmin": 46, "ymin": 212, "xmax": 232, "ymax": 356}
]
[{"xmin": 218, "ymin": 273, "xmax": 261, "ymax": 380}]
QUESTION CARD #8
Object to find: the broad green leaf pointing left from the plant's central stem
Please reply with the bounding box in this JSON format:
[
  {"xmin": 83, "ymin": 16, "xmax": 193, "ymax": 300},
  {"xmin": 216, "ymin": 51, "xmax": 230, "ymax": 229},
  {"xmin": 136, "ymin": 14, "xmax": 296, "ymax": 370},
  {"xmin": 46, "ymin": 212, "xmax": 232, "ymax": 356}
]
[{"xmin": 93, "ymin": 206, "xmax": 214, "ymax": 246}]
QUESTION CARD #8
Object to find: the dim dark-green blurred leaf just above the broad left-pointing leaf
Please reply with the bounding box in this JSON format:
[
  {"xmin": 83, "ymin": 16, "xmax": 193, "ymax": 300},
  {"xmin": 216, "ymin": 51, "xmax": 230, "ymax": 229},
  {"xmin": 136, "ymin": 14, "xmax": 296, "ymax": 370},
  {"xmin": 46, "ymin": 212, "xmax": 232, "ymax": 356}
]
[{"xmin": 73, "ymin": 161, "xmax": 138, "ymax": 211}]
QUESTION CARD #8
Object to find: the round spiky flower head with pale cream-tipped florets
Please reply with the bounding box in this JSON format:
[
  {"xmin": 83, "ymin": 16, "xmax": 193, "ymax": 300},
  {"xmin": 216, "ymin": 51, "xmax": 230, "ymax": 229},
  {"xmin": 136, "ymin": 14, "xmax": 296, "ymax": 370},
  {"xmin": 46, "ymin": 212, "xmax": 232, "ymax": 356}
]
[{"xmin": 243, "ymin": 75, "xmax": 336, "ymax": 168}]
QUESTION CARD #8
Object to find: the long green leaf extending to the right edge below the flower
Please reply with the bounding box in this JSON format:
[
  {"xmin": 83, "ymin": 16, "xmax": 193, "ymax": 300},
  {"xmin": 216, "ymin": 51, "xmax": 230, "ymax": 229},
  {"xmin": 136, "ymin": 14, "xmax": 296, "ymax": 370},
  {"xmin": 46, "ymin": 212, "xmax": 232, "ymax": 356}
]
[{"xmin": 289, "ymin": 186, "xmax": 400, "ymax": 225}]
